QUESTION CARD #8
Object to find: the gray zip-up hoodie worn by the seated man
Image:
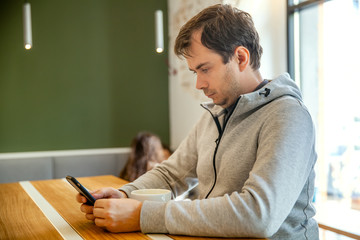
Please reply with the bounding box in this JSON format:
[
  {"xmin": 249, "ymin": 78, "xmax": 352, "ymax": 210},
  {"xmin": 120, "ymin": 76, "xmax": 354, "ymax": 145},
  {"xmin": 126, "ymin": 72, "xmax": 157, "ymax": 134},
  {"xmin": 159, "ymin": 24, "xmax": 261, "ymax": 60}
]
[{"xmin": 121, "ymin": 74, "xmax": 319, "ymax": 240}]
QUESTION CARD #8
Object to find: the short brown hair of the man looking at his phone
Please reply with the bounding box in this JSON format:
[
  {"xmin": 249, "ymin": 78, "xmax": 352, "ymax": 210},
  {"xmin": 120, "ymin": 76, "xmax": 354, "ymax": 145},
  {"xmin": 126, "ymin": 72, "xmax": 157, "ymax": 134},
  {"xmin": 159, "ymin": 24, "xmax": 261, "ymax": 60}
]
[{"xmin": 174, "ymin": 4, "xmax": 262, "ymax": 70}]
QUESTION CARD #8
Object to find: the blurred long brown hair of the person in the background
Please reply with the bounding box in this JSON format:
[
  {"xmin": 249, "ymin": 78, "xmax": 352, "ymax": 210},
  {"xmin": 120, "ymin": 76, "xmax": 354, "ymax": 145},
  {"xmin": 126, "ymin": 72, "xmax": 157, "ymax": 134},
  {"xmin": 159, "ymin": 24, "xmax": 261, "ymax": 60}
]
[{"xmin": 120, "ymin": 132, "xmax": 164, "ymax": 181}]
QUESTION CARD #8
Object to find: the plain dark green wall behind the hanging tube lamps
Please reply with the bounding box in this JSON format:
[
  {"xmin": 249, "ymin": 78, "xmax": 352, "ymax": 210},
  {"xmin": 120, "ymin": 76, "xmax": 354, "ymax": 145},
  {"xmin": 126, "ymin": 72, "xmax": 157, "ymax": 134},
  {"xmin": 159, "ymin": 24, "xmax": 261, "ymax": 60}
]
[{"xmin": 0, "ymin": 0, "xmax": 169, "ymax": 152}]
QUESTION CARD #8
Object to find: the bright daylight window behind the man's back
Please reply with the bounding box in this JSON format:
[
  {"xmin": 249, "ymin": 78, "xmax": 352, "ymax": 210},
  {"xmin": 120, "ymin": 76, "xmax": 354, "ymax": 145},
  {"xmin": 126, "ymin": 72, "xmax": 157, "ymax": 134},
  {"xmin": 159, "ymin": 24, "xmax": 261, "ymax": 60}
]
[{"xmin": 288, "ymin": 0, "xmax": 360, "ymax": 238}]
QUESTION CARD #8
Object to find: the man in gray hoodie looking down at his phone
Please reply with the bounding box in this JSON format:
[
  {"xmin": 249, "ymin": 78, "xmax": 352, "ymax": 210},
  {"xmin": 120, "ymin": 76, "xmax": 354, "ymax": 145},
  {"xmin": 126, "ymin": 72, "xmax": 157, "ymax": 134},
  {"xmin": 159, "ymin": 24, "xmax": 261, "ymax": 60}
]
[{"xmin": 77, "ymin": 5, "xmax": 318, "ymax": 239}]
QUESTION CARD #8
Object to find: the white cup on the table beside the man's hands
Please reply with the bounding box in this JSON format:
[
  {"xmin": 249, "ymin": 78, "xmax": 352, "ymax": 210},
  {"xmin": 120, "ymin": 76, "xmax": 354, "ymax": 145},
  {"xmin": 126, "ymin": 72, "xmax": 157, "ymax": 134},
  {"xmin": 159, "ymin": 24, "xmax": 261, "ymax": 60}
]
[{"xmin": 130, "ymin": 189, "xmax": 171, "ymax": 202}]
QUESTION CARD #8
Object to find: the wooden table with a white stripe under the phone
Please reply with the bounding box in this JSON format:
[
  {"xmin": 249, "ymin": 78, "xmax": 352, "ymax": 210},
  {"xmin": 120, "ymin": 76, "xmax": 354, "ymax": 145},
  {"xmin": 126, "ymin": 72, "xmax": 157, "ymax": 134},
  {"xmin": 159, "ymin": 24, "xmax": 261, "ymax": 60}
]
[{"xmin": 0, "ymin": 176, "xmax": 264, "ymax": 240}]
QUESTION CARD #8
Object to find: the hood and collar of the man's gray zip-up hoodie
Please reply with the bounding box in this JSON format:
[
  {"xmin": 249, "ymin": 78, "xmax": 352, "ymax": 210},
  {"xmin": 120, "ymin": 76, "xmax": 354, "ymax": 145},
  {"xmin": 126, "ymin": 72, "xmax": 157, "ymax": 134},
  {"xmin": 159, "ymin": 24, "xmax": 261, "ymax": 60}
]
[{"xmin": 201, "ymin": 73, "xmax": 302, "ymax": 117}]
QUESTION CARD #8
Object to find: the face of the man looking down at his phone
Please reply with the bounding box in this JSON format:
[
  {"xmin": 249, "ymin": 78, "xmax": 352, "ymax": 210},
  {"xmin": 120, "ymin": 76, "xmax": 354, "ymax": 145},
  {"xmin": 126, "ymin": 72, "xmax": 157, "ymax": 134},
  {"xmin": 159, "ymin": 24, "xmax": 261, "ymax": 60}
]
[{"xmin": 186, "ymin": 31, "xmax": 242, "ymax": 108}]
